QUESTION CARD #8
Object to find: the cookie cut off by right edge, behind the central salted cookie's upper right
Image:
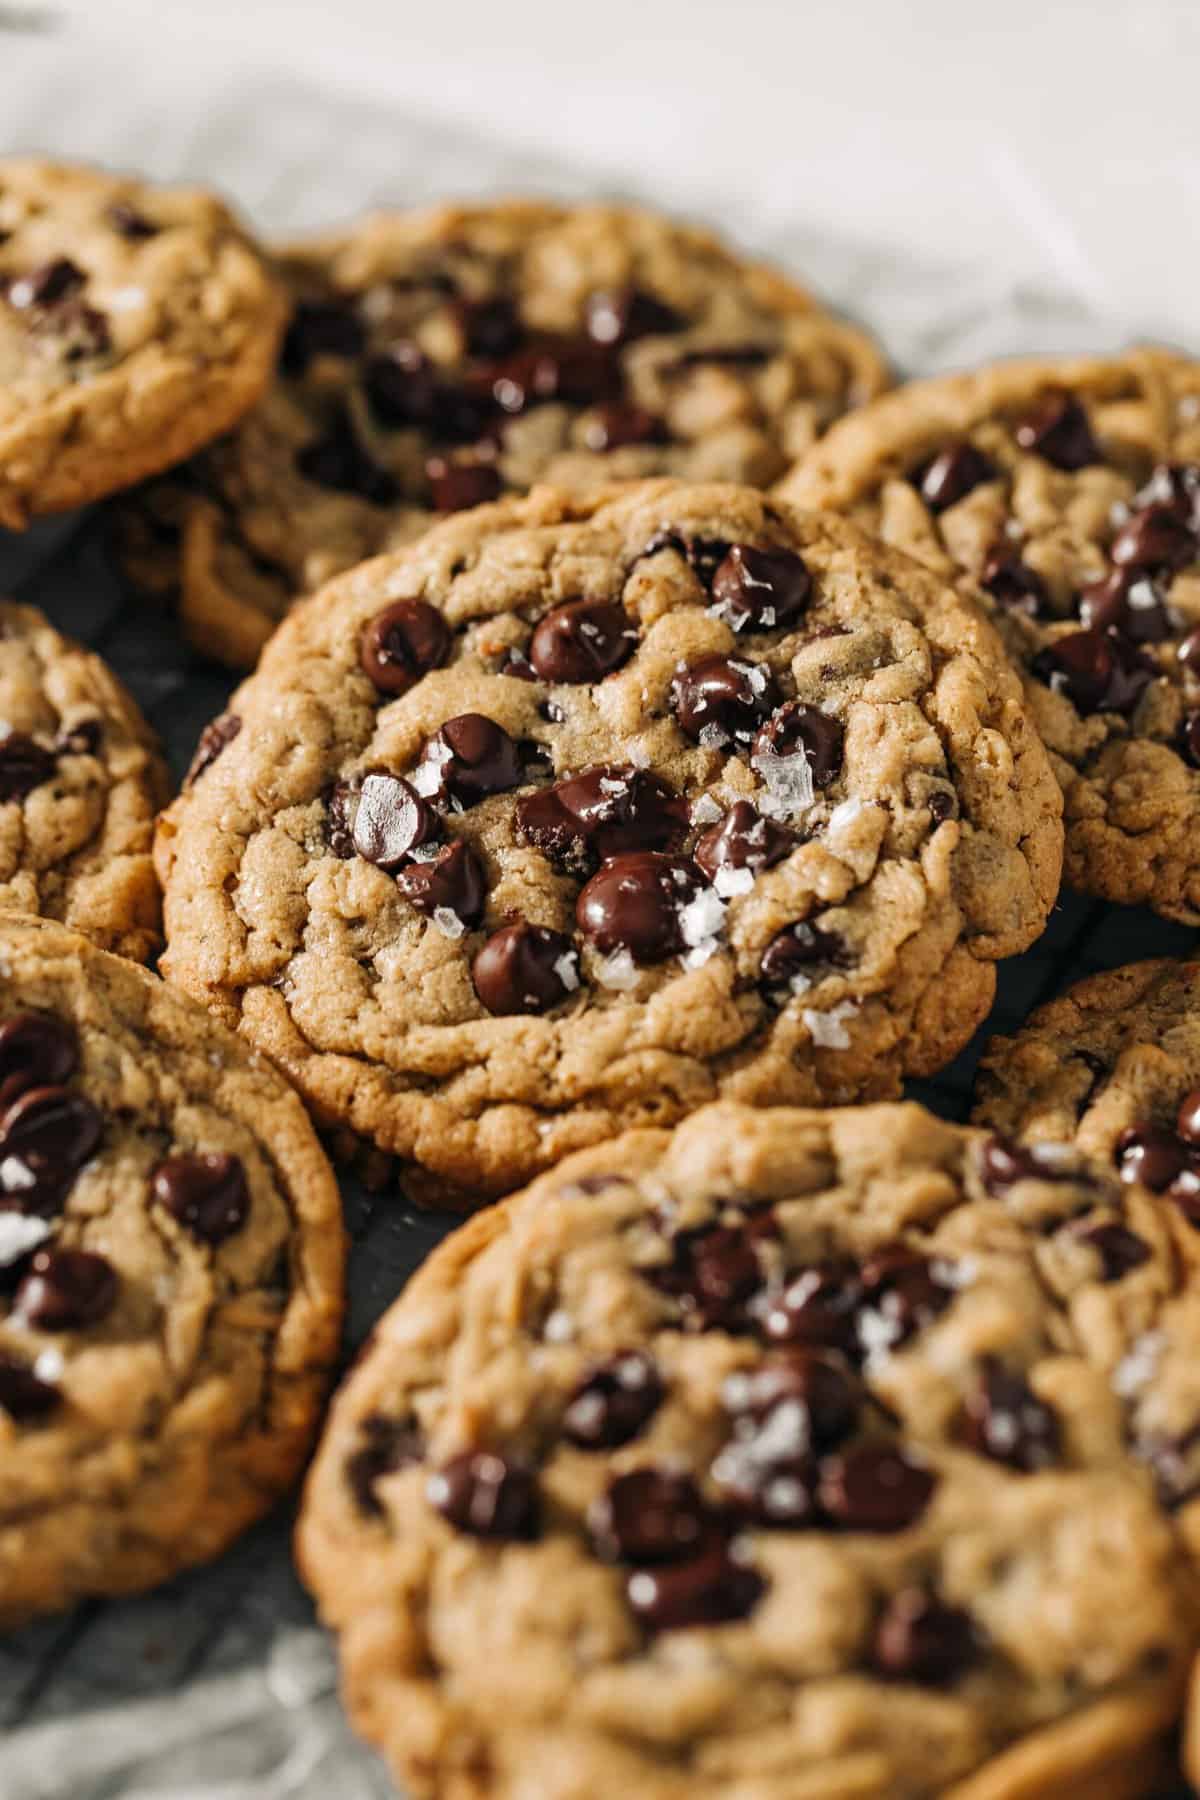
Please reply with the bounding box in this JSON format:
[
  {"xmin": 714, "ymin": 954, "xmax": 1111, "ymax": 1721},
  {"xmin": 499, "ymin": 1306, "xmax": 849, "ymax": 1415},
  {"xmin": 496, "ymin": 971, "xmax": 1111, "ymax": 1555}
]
[{"xmin": 783, "ymin": 349, "xmax": 1200, "ymax": 925}]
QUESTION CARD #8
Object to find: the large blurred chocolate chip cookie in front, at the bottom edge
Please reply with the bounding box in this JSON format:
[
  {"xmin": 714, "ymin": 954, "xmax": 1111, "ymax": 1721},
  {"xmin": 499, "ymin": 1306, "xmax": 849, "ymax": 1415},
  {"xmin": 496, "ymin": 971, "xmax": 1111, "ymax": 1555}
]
[{"xmin": 297, "ymin": 1105, "xmax": 1200, "ymax": 1800}]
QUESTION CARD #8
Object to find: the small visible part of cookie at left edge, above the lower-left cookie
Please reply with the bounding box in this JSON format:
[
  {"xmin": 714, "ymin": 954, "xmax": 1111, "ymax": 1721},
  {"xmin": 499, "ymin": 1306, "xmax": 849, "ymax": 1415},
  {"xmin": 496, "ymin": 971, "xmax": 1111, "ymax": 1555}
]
[{"xmin": 0, "ymin": 601, "xmax": 167, "ymax": 961}]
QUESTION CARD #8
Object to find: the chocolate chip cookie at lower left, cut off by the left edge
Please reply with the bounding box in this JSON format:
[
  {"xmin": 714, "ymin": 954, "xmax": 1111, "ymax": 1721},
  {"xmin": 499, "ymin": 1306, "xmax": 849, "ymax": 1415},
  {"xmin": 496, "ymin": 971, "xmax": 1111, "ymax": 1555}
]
[{"xmin": 0, "ymin": 913, "xmax": 342, "ymax": 1627}]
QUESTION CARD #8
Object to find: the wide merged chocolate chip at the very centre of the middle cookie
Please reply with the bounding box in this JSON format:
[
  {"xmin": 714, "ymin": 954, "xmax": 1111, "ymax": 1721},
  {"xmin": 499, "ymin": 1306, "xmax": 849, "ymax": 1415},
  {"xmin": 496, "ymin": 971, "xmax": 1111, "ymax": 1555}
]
[{"xmin": 516, "ymin": 763, "xmax": 687, "ymax": 862}]
